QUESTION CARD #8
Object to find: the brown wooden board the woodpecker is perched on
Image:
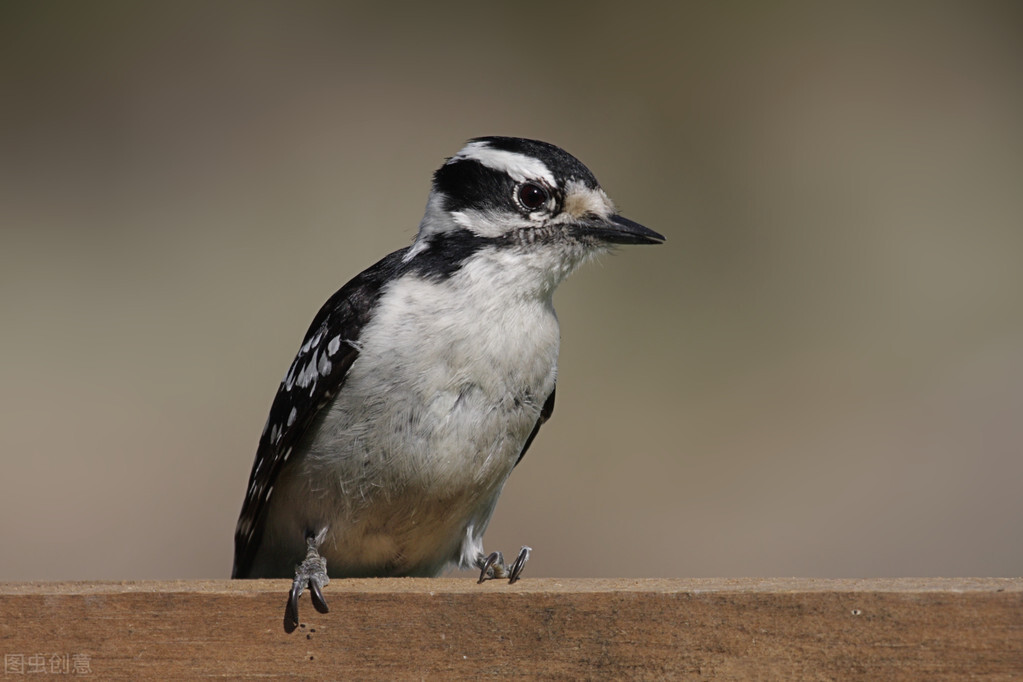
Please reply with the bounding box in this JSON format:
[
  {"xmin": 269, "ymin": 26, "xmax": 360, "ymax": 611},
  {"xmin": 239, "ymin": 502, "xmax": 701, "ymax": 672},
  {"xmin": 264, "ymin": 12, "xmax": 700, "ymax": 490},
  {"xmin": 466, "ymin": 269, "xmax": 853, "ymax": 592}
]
[{"xmin": 0, "ymin": 578, "xmax": 1023, "ymax": 680}]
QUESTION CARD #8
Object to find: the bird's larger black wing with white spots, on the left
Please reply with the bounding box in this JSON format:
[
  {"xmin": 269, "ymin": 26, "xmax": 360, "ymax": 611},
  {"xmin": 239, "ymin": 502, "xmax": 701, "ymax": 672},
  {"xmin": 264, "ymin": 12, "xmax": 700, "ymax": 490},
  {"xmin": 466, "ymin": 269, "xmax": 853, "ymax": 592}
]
[{"xmin": 231, "ymin": 249, "xmax": 407, "ymax": 578}]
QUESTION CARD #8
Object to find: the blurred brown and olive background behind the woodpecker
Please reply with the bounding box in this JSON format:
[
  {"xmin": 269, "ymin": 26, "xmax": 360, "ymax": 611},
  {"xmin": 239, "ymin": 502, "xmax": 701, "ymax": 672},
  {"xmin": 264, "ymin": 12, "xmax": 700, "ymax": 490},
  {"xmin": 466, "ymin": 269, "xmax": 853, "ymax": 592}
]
[{"xmin": 0, "ymin": 1, "xmax": 1023, "ymax": 580}]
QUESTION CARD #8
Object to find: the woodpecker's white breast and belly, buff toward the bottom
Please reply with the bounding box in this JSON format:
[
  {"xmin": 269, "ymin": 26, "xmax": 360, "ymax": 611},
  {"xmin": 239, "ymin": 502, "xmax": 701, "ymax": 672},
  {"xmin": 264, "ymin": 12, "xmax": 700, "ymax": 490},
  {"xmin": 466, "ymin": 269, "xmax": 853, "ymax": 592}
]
[{"xmin": 272, "ymin": 252, "xmax": 559, "ymax": 575}]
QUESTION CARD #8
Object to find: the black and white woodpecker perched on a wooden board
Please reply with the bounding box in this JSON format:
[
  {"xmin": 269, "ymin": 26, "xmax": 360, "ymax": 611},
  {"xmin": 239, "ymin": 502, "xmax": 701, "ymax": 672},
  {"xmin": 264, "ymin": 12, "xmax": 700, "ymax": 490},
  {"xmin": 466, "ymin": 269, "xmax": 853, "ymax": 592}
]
[{"xmin": 232, "ymin": 137, "xmax": 664, "ymax": 631}]
